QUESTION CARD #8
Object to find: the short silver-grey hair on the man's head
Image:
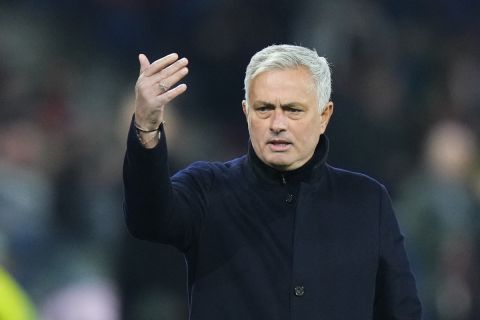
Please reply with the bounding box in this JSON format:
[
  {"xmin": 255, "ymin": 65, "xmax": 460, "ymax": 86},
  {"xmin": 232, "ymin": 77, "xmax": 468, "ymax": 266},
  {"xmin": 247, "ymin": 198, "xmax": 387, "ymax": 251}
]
[{"xmin": 244, "ymin": 44, "xmax": 332, "ymax": 112}]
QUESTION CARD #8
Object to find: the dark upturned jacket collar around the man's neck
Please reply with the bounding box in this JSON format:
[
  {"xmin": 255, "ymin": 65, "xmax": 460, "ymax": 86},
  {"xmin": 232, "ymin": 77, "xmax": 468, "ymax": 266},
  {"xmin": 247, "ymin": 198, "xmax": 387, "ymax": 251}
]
[{"xmin": 247, "ymin": 135, "xmax": 329, "ymax": 184}]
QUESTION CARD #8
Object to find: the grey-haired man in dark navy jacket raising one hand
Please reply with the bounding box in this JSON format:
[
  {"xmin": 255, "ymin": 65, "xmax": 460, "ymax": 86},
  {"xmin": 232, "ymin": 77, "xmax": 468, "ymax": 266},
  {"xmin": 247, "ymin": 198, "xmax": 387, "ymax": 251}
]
[{"xmin": 124, "ymin": 45, "xmax": 421, "ymax": 320}]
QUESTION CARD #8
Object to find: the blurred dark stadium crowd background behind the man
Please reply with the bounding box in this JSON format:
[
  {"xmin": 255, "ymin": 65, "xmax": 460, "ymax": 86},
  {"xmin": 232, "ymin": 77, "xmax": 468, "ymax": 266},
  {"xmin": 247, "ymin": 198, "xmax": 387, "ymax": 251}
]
[{"xmin": 0, "ymin": 0, "xmax": 480, "ymax": 320}]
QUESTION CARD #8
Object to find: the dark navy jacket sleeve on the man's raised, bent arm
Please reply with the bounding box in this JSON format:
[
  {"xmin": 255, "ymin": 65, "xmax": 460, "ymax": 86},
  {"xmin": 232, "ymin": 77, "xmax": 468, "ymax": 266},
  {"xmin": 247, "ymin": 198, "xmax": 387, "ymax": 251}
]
[{"xmin": 123, "ymin": 120, "xmax": 212, "ymax": 252}]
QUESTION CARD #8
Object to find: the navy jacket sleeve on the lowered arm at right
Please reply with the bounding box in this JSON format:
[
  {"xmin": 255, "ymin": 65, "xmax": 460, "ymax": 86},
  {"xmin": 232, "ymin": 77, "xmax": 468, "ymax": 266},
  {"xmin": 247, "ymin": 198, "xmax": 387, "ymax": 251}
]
[{"xmin": 374, "ymin": 186, "xmax": 421, "ymax": 320}]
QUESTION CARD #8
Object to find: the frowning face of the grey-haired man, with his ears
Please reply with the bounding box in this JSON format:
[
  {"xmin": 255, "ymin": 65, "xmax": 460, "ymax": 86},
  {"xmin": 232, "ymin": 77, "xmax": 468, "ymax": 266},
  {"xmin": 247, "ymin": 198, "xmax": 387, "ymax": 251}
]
[{"xmin": 242, "ymin": 67, "xmax": 333, "ymax": 171}]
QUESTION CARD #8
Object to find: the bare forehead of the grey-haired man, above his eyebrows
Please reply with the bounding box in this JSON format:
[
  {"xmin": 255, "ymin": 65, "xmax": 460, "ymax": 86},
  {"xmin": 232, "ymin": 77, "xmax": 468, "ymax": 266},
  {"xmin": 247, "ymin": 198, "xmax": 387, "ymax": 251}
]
[{"xmin": 248, "ymin": 67, "xmax": 316, "ymax": 103}]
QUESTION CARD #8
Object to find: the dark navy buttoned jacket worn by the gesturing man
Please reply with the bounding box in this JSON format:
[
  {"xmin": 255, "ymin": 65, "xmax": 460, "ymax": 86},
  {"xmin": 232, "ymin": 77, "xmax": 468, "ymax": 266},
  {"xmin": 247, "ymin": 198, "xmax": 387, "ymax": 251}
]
[{"xmin": 124, "ymin": 121, "xmax": 421, "ymax": 320}]
